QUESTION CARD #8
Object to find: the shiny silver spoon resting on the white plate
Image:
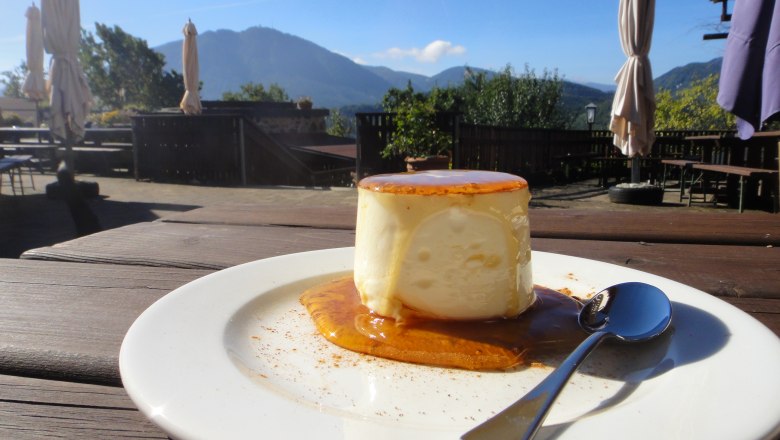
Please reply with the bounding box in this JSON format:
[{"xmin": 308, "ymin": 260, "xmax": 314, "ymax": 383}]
[{"xmin": 461, "ymin": 282, "xmax": 672, "ymax": 440}]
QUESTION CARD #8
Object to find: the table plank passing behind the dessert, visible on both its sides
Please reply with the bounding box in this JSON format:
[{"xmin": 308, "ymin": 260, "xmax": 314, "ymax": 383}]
[{"xmin": 22, "ymin": 222, "xmax": 780, "ymax": 298}]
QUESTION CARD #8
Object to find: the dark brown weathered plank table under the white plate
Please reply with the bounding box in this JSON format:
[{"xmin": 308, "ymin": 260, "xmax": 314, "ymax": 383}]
[{"xmin": 0, "ymin": 205, "xmax": 780, "ymax": 438}]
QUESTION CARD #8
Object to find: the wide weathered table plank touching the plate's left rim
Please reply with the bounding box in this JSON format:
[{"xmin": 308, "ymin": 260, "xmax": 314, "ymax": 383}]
[{"xmin": 0, "ymin": 259, "xmax": 210, "ymax": 385}]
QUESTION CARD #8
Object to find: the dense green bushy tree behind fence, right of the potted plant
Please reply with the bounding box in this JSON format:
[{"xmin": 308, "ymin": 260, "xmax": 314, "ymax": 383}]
[{"xmin": 461, "ymin": 66, "xmax": 565, "ymax": 128}]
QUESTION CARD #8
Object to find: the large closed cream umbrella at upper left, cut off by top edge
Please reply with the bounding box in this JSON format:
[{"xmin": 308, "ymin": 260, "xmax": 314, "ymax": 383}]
[{"xmin": 41, "ymin": 0, "xmax": 92, "ymax": 146}]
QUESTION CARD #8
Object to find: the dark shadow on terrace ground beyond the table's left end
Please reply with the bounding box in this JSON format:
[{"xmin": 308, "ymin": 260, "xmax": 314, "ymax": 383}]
[{"xmin": 0, "ymin": 194, "xmax": 200, "ymax": 258}]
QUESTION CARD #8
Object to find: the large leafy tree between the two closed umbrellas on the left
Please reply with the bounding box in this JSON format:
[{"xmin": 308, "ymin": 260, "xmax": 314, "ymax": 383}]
[{"xmin": 79, "ymin": 23, "xmax": 184, "ymax": 109}]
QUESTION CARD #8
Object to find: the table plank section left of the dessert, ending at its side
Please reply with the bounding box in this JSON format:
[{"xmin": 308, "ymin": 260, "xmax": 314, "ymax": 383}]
[{"xmin": 21, "ymin": 222, "xmax": 355, "ymax": 269}]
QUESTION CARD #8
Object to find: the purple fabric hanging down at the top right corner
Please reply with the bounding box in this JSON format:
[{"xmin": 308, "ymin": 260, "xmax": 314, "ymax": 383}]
[{"xmin": 718, "ymin": 0, "xmax": 780, "ymax": 139}]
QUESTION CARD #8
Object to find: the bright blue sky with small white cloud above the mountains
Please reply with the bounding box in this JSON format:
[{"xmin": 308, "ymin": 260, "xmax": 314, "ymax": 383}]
[{"xmin": 0, "ymin": 0, "xmax": 724, "ymax": 84}]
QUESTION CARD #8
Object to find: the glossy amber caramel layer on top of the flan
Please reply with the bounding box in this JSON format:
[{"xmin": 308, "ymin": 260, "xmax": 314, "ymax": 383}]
[{"xmin": 358, "ymin": 170, "xmax": 528, "ymax": 195}]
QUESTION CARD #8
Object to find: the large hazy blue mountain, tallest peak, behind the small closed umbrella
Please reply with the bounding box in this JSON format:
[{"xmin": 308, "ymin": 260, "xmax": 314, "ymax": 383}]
[{"xmin": 154, "ymin": 26, "xmax": 390, "ymax": 107}]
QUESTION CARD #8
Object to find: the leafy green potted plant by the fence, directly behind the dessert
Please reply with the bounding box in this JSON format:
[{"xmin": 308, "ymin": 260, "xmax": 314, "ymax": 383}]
[{"xmin": 382, "ymin": 99, "xmax": 452, "ymax": 171}]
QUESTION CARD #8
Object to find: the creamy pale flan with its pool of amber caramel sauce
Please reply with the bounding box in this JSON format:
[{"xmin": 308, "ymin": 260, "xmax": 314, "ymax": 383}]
[{"xmin": 301, "ymin": 170, "xmax": 585, "ymax": 370}]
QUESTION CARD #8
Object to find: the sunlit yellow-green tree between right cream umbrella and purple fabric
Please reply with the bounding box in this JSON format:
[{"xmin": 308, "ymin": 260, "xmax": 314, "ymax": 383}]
[{"xmin": 655, "ymin": 74, "xmax": 736, "ymax": 130}]
